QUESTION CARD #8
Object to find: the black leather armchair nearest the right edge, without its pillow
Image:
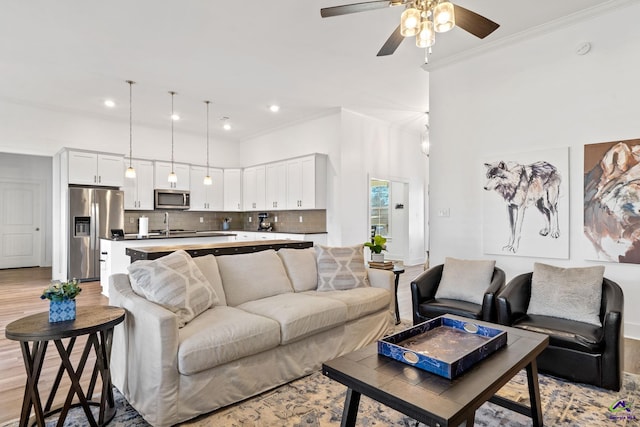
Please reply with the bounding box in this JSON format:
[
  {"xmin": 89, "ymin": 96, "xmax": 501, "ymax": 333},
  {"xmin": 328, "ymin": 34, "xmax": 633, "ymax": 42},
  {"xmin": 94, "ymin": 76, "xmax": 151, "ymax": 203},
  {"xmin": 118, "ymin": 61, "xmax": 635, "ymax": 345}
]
[{"xmin": 497, "ymin": 273, "xmax": 624, "ymax": 391}]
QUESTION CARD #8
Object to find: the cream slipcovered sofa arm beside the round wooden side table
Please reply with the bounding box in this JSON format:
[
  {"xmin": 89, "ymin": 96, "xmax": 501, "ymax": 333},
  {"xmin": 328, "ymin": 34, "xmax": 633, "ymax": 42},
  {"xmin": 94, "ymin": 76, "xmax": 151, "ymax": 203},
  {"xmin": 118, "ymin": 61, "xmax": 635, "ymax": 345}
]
[{"xmin": 109, "ymin": 274, "xmax": 179, "ymax": 420}]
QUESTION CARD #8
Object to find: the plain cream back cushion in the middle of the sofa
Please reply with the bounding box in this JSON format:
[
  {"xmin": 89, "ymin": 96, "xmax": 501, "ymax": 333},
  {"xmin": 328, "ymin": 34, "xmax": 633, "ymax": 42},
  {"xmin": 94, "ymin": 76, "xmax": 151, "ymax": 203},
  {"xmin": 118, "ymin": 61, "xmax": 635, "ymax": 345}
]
[{"xmin": 216, "ymin": 249, "xmax": 293, "ymax": 307}]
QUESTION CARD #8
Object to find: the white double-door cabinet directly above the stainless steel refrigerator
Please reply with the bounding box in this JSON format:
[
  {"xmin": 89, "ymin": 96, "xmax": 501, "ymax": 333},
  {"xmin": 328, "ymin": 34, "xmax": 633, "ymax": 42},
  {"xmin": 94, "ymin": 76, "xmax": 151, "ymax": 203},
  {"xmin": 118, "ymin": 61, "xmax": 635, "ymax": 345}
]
[{"xmin": 68, "ymin": 150, "xmax": 124, "ymax": 187}]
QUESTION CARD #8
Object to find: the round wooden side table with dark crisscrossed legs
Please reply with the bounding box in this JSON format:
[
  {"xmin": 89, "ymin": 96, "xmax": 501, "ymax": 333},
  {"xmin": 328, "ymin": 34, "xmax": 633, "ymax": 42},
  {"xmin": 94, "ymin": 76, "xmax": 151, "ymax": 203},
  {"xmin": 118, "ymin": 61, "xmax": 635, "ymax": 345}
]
[{"xmin": 5, "ymin": 306, "xmax": 125, "ymax": 427}]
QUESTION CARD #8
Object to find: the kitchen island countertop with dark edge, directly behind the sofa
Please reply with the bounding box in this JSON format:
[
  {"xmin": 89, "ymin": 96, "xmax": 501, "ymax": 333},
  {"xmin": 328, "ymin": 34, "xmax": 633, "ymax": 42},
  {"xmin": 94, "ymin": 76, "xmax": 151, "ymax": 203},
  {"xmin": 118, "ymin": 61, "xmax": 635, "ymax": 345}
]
[{"xmin": 126, "ymin": 240, "xmax": 313, "ymax": 263}]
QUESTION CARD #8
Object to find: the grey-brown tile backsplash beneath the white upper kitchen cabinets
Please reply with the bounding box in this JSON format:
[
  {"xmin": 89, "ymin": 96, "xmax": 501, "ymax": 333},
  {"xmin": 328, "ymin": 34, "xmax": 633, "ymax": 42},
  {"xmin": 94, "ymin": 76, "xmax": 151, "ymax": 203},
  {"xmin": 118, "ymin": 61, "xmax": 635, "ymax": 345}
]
[{"xmin": 124, "ymin": 209, "xmax": 327, "ymax": 234}]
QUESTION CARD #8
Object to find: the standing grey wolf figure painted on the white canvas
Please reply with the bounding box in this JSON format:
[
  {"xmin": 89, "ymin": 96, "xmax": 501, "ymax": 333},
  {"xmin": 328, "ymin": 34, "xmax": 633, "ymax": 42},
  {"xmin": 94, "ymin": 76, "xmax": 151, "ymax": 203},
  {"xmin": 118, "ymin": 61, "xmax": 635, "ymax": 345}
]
[{"xmin": 484, "ymin": 161, "xmax": 562, "ymax": 253}]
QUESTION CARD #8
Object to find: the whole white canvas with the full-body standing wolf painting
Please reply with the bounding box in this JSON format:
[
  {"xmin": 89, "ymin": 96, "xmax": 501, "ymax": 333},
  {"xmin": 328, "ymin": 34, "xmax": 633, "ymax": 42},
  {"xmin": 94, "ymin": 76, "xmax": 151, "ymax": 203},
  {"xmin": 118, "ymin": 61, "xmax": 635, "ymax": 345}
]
[{"xmin": 482, "ymin": 148, "xmax": 569, "ymax": 259}]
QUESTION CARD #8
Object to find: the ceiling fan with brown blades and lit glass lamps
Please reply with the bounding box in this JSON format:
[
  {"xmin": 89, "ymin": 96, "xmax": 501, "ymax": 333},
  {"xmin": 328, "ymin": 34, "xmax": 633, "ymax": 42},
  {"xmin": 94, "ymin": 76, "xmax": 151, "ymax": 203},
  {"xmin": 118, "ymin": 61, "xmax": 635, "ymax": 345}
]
[{"xmin": 320, "ymin": 0, "xmax": 500, "ymax": 56}]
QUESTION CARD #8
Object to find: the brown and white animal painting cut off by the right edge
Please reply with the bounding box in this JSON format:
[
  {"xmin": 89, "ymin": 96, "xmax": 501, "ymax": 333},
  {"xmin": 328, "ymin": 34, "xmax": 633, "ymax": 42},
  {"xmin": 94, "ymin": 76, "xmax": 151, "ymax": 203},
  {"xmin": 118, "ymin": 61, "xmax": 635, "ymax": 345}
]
[{"xmin": 584, "ymin": 139, "xmax": 640, "ymax": 264}]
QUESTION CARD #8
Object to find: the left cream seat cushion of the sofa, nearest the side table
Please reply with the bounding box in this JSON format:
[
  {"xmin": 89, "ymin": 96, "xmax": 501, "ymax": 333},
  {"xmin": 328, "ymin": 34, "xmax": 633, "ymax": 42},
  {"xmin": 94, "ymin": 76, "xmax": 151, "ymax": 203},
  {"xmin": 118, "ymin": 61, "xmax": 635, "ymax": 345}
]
[{"xmin": 178, "ymin": 306, "xmax": 280, "ymax": 375}]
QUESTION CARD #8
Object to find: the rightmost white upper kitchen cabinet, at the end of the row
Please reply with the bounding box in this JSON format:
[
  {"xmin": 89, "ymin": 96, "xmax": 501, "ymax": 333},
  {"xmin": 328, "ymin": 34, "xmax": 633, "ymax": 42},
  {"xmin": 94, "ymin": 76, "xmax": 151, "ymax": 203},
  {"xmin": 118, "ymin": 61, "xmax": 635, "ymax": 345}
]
[{"xmin": 286, "ymin": 154, "xmax": 327, "ymax": 209}]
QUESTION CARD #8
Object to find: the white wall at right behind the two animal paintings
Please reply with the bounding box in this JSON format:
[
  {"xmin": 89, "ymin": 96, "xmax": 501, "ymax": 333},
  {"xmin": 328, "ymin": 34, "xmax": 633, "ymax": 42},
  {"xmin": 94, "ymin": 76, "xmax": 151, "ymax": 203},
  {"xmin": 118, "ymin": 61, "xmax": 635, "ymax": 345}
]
[{"xmin": 430, "ymin": 2, "xmax": 640, "ymax": 338}]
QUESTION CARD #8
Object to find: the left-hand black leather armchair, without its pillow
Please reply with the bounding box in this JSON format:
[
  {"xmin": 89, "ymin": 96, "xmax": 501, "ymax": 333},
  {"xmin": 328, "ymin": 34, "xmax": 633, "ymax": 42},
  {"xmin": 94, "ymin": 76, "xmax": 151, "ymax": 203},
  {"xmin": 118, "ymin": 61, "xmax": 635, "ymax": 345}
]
[{"xmin": 411, "ymin": 264, "xmax": 505, "ymax": 325}]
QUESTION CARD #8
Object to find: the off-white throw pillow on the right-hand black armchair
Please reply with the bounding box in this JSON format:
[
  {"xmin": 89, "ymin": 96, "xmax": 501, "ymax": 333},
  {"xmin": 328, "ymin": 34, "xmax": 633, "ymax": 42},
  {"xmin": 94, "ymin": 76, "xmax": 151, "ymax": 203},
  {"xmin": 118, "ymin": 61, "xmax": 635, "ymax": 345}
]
[{"xmin": 527, "ymin": 262, "xmax": 604, "ymax": 326}]
